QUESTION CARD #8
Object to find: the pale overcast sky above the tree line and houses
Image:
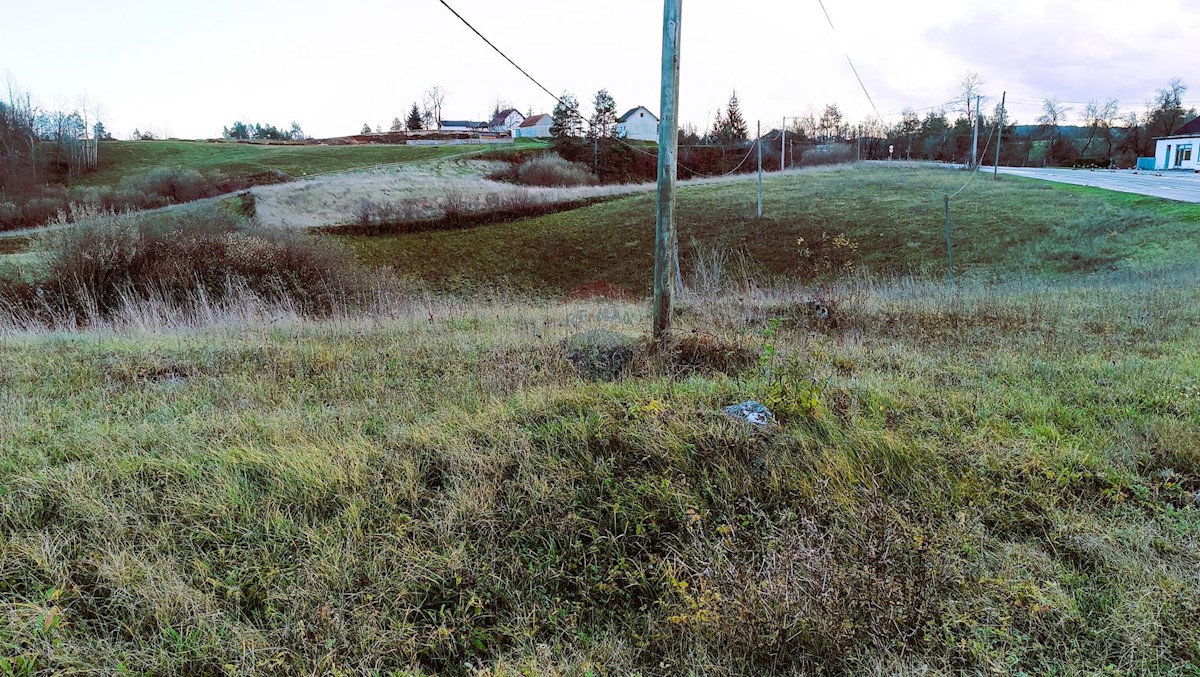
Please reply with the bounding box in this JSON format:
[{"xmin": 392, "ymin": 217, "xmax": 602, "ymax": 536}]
[{"xmin": 0, "ymin": 0, "xmax": 1200, "ymax": 138}]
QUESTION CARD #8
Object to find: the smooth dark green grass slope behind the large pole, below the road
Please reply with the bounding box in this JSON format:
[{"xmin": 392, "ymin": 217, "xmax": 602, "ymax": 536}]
[{"xmin": 336, "ymin": 168, "xmax": 1200, "ymax": 294}]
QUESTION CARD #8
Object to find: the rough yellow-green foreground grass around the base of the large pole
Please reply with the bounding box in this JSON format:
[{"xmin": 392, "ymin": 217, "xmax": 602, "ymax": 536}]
[{"xmin": 0, "ymin": 280, "xmax": 1200, "ymax": 675}]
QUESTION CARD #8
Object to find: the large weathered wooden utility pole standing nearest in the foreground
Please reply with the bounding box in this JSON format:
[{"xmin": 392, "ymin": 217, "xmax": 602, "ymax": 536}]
[{"xmin": 653, "ymin": 0, "xmax": 683, "ymax": 343}]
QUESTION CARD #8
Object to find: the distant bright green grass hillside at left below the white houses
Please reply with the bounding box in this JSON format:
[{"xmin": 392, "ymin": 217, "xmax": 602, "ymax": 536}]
[{"xmin": 80, "ymin": 142, "xmax": 542, "ymax": 186}]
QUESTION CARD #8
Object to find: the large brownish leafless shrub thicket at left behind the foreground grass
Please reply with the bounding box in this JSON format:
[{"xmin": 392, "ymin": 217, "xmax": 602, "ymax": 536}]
[{"xmin": 0, "ymin": 209, "xmax": 360, "ymax": 323}]
